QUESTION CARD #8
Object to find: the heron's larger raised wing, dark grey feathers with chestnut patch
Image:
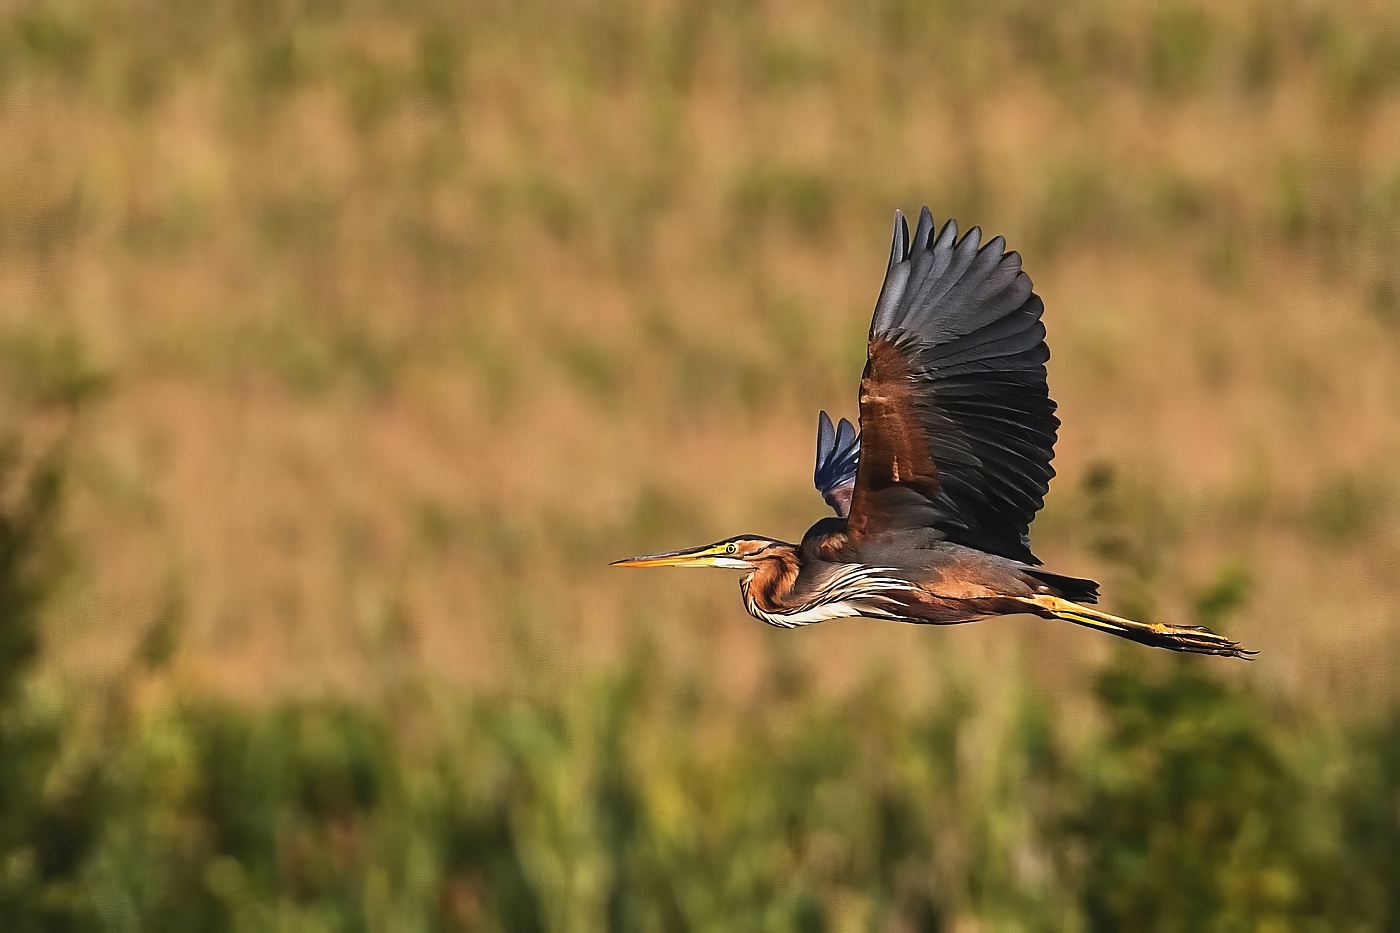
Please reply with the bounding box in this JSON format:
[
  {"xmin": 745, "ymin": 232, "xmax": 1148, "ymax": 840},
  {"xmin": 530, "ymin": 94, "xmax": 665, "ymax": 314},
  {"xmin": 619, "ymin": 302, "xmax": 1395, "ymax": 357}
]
[{"xmin": 848, "ymin": 207, "xmax": 1060, "ymax": 563}]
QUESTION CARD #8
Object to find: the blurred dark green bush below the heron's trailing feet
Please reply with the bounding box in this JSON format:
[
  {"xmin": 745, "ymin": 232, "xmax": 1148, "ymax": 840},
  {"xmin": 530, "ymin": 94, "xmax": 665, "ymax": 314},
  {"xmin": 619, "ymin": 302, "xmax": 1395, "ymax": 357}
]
[{"xmin": 1070, "ymin": 664, "xmax": 1359, "ymax": 930}]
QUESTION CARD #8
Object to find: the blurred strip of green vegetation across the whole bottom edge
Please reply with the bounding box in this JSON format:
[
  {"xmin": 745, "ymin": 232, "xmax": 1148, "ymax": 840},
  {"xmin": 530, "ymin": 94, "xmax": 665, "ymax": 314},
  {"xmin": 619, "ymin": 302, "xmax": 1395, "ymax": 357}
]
[{"xmin": 0, "ymin": 560, "xmax": 1400, "ymax": 930}]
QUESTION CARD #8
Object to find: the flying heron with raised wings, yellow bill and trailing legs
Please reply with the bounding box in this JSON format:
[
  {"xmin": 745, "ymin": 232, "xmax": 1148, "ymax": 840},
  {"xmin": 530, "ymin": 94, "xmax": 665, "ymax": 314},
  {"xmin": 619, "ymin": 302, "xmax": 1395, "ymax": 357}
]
[{"xmin": 613, "ymin": 206, "xmax": 1254, "ymax": 658}]
